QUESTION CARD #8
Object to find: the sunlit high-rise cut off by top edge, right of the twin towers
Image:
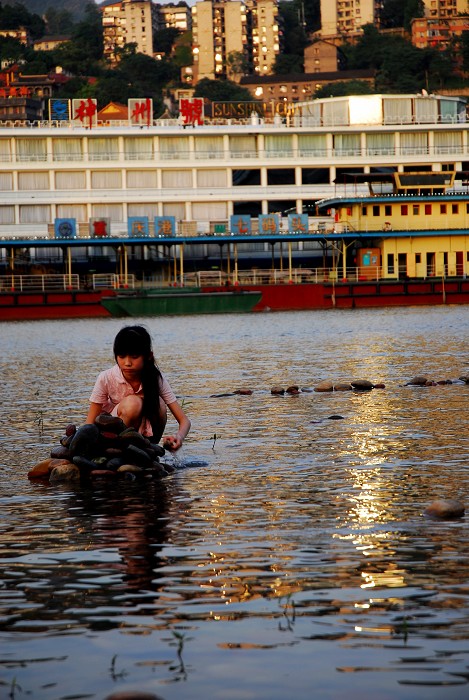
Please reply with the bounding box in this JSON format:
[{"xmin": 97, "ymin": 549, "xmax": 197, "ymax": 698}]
[{"xmin": 321, "ymin": 0, "xmax": 380, "ymax": 36}]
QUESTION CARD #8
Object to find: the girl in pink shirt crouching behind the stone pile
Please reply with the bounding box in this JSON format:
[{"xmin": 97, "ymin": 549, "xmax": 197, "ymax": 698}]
[{"xmin": 86, "ymin": 326, "xmax": 191, "ymax": 450}]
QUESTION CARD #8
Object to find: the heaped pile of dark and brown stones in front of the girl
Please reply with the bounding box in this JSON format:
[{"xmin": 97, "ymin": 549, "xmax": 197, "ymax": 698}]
[{"xmin": 28, "ymin": 413, "xmax": 174, "ymax": 482}]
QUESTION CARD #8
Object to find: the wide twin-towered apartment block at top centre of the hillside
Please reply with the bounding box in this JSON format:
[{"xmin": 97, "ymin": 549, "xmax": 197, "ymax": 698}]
[{"xmin": 192, "ymin": 0, "xmax": 280, "ymax": 81}]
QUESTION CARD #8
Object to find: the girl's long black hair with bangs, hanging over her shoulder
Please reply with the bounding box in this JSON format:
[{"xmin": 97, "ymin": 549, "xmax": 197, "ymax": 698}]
[{"xmin": 113, "ymin": 326, "xmax": 161, "ymax": 423}]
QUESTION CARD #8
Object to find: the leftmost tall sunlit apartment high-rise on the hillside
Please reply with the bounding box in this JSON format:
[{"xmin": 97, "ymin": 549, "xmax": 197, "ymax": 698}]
[{"xmin": 101, "ymin": 0, "xmax": 156, "ymax": 63}]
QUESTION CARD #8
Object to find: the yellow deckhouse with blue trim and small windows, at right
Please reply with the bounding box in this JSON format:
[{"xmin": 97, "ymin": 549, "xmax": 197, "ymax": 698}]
[{"xmin": 318, "ymin": 171, "xmax": 469, "ymax": 279}]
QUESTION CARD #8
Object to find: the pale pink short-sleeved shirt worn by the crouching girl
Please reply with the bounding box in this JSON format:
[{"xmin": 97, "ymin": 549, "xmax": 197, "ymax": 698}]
[{"xmin": 90, "ymin": 364, "xmax": 177, "ymax": 436}]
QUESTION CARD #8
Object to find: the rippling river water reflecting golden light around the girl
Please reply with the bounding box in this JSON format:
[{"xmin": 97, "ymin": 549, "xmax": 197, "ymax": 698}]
[{"xmin": 0, "ymin": 306, "xmax": 469, "ymax": 700}]
